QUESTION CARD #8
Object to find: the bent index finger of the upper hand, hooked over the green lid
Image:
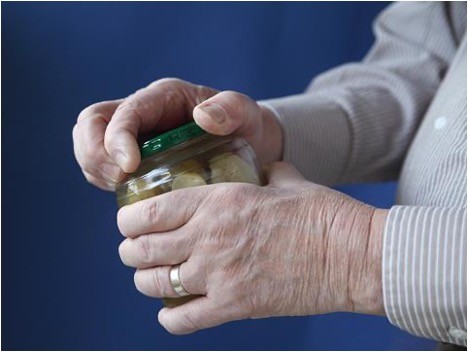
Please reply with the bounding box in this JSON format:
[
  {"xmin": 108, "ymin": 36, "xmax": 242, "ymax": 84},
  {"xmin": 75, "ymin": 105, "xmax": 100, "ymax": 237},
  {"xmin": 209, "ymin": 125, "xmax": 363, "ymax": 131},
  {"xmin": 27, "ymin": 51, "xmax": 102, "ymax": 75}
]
[{"xmin": 104, "ymin": 79, "xmax": 215, "ymax": 173}]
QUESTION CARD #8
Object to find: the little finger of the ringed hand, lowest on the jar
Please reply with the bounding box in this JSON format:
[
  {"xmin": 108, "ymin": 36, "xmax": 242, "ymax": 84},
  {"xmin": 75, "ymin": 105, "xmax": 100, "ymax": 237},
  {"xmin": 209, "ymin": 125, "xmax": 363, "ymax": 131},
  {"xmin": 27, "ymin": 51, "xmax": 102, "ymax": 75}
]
[{"xmin": 158, "ymin": 296, "xmax": 242, "ymax": 335}]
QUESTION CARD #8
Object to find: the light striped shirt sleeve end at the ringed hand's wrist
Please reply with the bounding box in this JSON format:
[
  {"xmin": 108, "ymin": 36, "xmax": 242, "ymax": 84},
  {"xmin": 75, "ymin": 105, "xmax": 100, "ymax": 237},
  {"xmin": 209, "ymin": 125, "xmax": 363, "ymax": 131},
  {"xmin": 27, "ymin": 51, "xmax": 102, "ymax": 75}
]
[{"xmin": 382, "ymin": 206, "xmax": 467, "ymax": 346}]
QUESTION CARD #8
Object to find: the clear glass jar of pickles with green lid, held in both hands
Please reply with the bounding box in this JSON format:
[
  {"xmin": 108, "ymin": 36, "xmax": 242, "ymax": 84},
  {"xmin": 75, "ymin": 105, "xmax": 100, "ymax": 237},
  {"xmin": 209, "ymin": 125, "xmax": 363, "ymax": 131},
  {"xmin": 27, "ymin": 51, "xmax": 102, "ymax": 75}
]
[{"xmin": 116, "ymin": 122, "xmax": 263, "ymax": 307}]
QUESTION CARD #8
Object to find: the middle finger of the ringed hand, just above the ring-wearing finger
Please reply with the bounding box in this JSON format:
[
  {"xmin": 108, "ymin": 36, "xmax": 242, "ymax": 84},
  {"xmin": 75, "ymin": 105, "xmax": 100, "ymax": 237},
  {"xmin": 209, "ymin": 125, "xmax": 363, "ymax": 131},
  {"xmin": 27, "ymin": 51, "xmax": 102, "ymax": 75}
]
[{"xmin": 119, "ymin": 230, "xmax": 192, "ymax": 269}]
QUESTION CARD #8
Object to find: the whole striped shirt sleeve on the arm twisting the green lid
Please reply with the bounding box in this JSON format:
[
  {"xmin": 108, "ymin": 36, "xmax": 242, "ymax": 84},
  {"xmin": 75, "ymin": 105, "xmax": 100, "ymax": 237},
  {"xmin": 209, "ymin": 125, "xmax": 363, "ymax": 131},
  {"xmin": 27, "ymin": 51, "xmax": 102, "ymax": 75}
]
[{"xmin": 260, "ymin": 2, "xmax": 460, "ymax": 185}]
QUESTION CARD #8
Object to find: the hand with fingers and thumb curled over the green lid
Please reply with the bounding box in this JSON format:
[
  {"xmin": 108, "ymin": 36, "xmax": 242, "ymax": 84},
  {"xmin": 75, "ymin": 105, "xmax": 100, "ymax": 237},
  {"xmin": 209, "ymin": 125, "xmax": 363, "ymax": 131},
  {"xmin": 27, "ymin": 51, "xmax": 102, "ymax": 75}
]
[{"xmin": 73, "ymin": 78, "xmax": 282, "ymax": 190}]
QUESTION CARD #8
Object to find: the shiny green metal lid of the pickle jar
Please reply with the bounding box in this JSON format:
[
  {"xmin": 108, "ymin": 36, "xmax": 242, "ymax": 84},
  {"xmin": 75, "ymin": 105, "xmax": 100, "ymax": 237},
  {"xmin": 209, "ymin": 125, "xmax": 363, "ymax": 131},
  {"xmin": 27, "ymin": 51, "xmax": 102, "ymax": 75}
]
[{"xmin": 140, "ymin": 122, "xmax": 206, "ymax": 158}]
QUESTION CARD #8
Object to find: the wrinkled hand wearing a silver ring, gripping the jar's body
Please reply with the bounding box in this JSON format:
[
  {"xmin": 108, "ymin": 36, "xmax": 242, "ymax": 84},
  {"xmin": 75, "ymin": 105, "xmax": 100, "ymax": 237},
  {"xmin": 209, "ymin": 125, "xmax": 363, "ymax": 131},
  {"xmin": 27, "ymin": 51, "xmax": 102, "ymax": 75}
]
[{"xmin": 118, "ymin": 163, "xmax": 386, "ymax": 334}]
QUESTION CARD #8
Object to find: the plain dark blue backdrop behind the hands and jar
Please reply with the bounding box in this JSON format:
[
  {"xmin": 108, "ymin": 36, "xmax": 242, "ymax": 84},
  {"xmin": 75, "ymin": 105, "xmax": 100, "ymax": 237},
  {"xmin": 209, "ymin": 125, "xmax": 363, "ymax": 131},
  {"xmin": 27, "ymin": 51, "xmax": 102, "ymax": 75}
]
[{"xmin": 2, "ymin": 3, "xmax": 435, "ymax": 350}]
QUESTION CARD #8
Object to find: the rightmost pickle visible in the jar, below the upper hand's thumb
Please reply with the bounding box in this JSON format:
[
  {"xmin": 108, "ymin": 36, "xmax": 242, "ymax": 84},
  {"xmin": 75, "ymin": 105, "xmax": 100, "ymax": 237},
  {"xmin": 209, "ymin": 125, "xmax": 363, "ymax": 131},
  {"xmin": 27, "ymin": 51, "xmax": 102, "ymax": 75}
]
[{"xmin": 210, "ymin": 153, "xmax": 260, "ymax": 185}]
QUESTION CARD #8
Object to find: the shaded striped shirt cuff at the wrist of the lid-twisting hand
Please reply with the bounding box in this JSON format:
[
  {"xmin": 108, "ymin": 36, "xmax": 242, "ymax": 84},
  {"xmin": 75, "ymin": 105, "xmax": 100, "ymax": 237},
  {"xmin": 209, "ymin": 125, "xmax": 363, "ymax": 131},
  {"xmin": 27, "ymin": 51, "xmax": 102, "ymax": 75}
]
[{"xmin": 259, "ymin": 94, "xmax": 351, "ymax": 185}]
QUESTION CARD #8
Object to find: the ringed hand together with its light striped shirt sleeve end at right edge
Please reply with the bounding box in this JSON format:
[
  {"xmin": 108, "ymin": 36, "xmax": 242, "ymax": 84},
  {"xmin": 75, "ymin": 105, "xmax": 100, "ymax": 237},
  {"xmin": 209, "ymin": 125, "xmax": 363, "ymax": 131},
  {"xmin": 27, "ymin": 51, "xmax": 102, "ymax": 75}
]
[{"xmin": 118, "ymin": 163, "xmax": 466, "ymax": 344}]
